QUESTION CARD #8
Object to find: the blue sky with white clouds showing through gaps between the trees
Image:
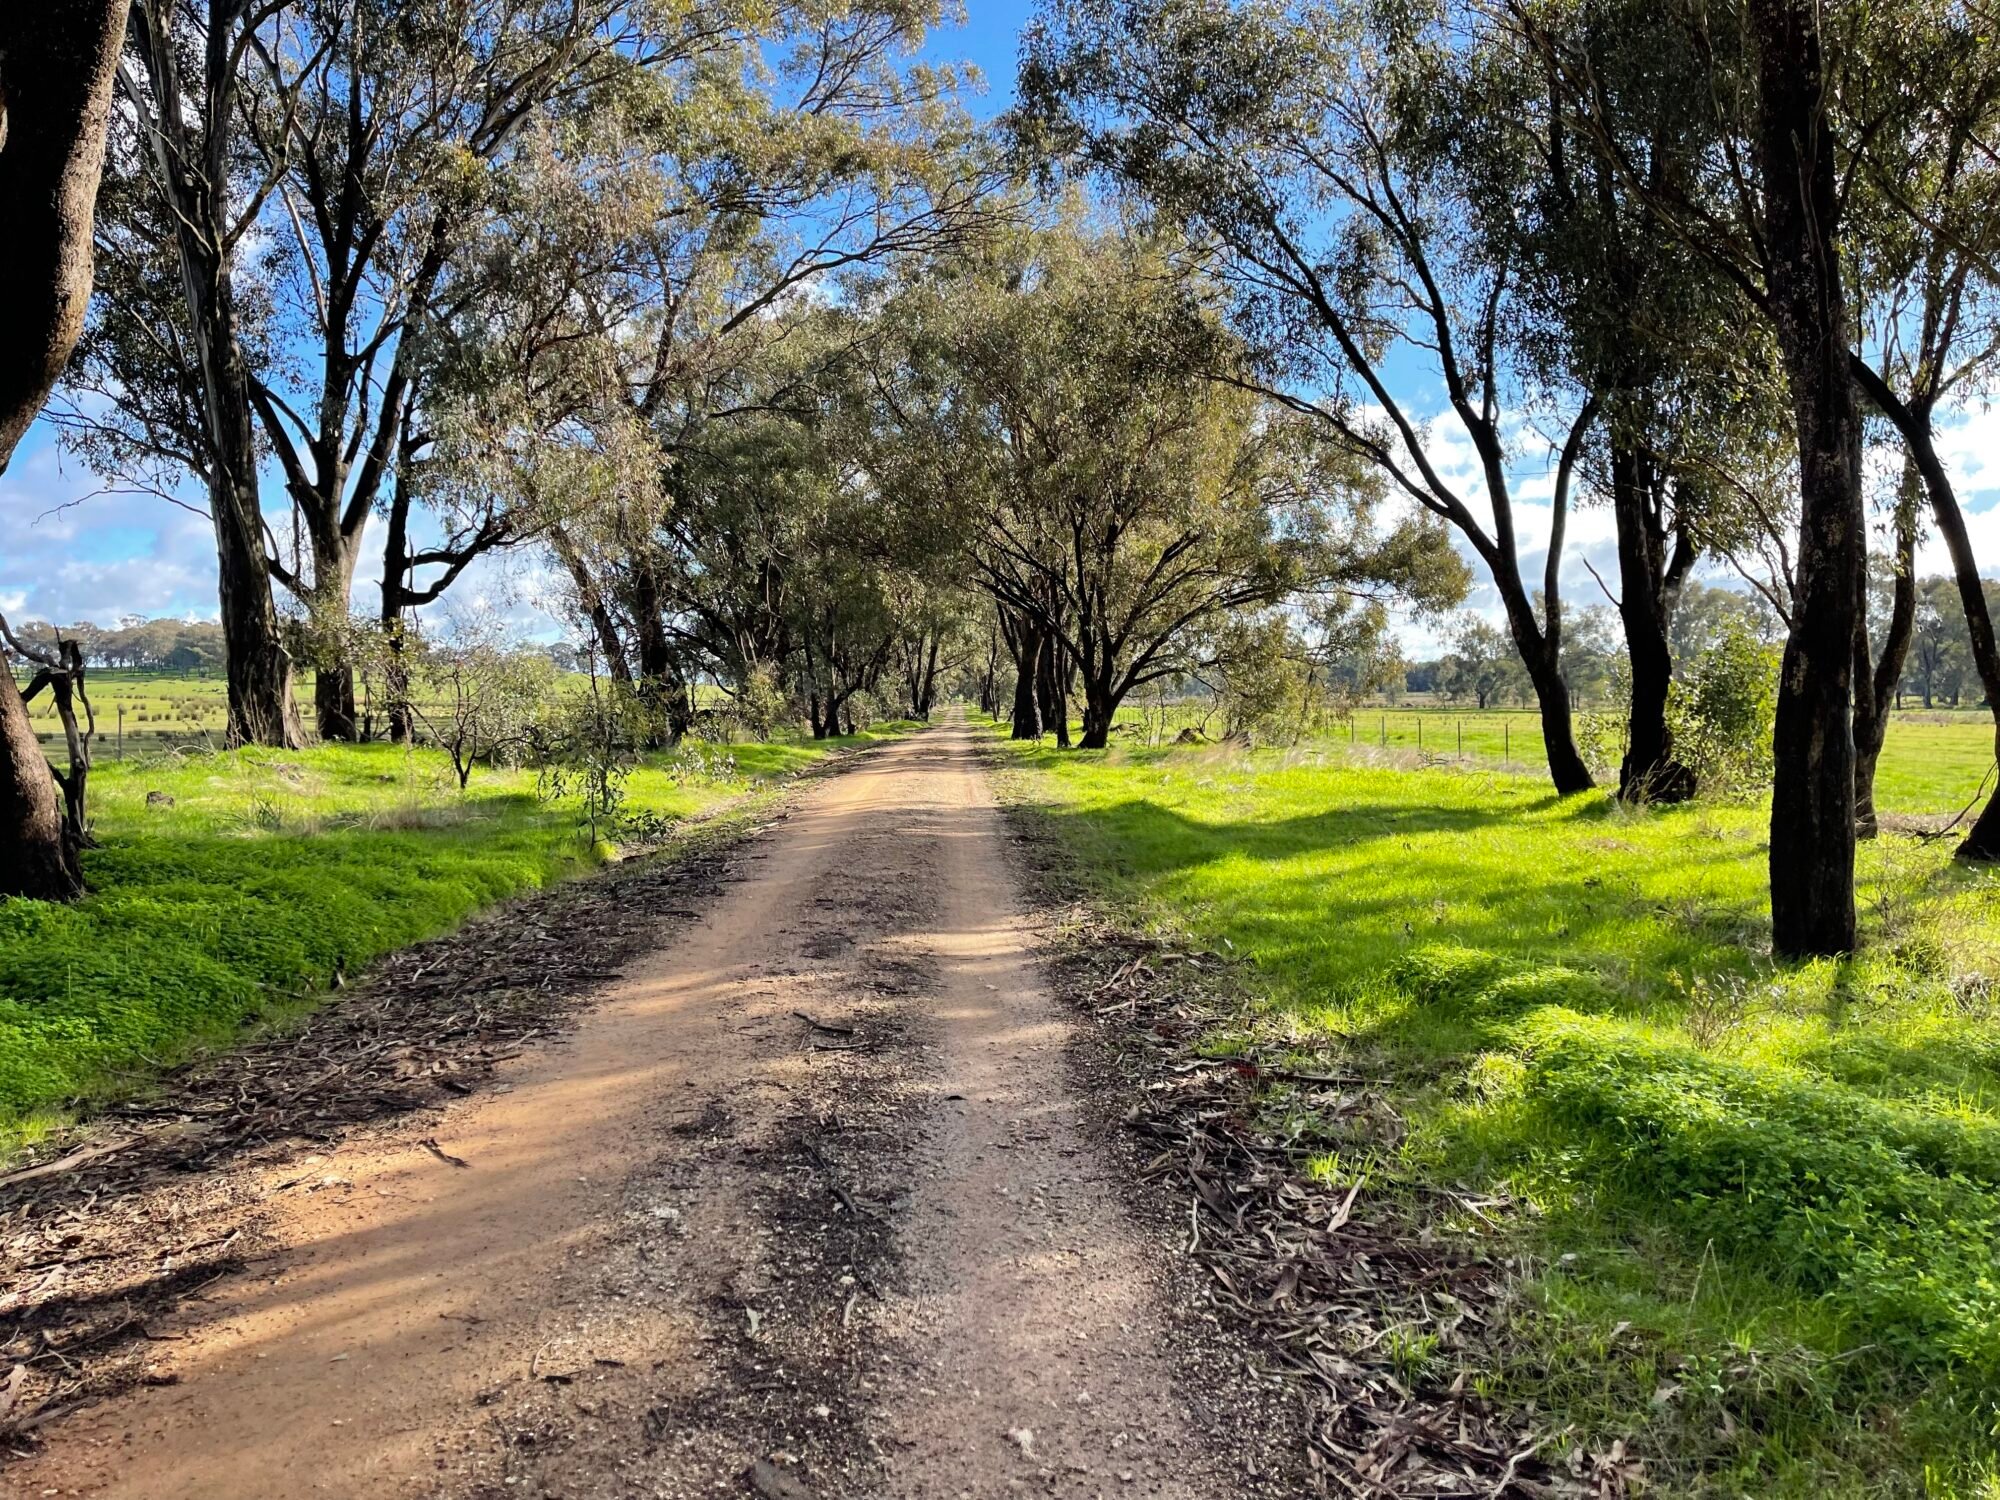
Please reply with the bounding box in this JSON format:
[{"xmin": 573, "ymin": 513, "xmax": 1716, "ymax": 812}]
[{"xmin": 0, "ymin": 0, "xmax": 2000, "ymax": 646}]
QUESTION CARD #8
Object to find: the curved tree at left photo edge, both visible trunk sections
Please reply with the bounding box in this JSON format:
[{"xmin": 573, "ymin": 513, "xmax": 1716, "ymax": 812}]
[{"xmin": 0, "ymin": 0, "xmax": 126, "ymax": 900}]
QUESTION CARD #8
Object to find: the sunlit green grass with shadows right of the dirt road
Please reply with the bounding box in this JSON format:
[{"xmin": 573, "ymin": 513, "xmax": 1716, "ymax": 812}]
[{"xmin": 1012, "ymin": 748, "xmax": 2000, "ymax": 1498}]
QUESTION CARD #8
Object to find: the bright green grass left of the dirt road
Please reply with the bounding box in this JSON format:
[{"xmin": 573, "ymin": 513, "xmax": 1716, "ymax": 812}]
[{"xmin": 0, "ymin": 730, "xmax": 908, "ymax": 1154}]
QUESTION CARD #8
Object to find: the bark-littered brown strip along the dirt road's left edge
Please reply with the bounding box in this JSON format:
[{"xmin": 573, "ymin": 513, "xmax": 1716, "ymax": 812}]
[{"xmin": 0, "ymin": 740, "xmax": 916, "ymax": 1472}]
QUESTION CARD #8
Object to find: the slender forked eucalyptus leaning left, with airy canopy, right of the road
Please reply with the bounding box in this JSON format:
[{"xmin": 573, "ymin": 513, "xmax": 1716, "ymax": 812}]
[{"xmin": 1016, "ymin": 0, "xmax": 1600, "ymax": 792}]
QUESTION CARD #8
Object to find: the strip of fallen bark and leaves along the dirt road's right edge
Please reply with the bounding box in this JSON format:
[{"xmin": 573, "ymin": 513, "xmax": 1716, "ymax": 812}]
[{"xmin": 980, "ymin": 740, "xmax": 1616, "ymax": 1500}]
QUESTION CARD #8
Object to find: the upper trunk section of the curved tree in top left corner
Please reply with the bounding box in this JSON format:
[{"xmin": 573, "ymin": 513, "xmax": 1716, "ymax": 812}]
[{"xmin": 0, "ymin": 0, "xmax": 128, "ymax": 474}]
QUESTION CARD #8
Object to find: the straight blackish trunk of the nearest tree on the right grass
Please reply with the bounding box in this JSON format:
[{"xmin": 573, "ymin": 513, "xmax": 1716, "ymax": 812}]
[{"xmin": 1750, "ymin": 0, "xmax": 1866, "ymax": 958}]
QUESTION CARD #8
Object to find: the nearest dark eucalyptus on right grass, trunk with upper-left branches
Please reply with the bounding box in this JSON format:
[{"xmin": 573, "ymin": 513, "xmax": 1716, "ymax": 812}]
[{"xmin": 1508, "ymin": 0, "xmax": 1866, "ymax": 956}]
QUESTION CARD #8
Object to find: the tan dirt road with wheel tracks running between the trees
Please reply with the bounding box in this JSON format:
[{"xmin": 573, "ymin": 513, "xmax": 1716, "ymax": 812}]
[{"xmin": 11, "ymin": 724, "xmax": 1288, "ymax": 1500}]
